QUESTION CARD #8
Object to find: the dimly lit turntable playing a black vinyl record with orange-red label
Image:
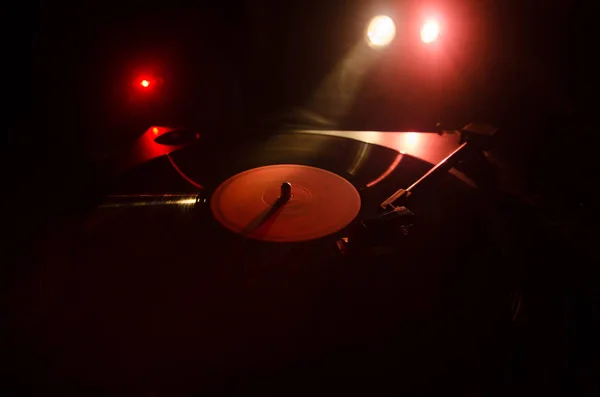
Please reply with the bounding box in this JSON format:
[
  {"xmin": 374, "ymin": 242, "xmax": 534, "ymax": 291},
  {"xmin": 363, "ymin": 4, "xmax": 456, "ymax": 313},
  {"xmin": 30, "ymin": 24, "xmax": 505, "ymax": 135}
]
[{"xmin": 30, "ymin": 126, "xmax": 509, "ymax": 395}]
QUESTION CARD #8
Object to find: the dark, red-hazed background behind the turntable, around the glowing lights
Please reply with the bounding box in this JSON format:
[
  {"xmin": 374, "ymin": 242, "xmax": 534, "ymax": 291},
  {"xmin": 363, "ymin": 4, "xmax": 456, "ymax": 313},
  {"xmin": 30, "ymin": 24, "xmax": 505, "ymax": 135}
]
[{"xmin": 2, "ymin": 0, "xmax": 597, "ymax": 392}]
